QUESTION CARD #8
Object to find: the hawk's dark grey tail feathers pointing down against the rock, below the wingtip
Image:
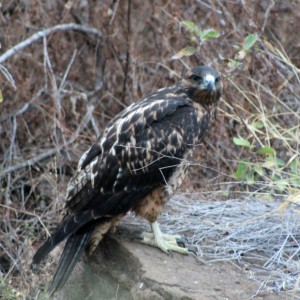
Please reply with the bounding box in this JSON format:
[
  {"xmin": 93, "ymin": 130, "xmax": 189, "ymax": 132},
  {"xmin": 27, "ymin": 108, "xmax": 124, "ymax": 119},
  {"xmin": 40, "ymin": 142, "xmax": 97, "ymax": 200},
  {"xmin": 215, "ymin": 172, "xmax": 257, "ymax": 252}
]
[{"xmin": 48, "ymin": 231, "xmax": 92, "ymax": 296}]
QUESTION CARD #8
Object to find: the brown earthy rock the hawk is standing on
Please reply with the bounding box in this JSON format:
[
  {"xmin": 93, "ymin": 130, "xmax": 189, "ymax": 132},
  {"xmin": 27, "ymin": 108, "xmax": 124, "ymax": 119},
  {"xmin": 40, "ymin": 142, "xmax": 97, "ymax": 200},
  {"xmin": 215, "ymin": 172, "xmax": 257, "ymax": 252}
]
[{"xmin": 56, "ymin": 227, "xmax": 284, "ymax": 300}]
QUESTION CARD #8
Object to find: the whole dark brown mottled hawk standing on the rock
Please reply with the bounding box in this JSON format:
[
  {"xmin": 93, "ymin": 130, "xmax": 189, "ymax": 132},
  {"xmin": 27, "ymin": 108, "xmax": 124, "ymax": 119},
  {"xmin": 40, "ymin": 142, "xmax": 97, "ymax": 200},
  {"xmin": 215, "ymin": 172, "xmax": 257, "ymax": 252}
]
[{"xmin": 32, "ymin": 66, "xmax": 222, "ymax": 294}]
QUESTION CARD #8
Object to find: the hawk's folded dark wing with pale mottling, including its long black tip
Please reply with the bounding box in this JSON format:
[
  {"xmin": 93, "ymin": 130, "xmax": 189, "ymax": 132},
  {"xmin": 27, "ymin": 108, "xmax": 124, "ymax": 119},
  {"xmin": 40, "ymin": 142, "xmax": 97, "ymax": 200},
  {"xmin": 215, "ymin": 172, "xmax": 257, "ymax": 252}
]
[{"xmin": 33, "ymin": 92, "xmax": 206, "ymax": 264}]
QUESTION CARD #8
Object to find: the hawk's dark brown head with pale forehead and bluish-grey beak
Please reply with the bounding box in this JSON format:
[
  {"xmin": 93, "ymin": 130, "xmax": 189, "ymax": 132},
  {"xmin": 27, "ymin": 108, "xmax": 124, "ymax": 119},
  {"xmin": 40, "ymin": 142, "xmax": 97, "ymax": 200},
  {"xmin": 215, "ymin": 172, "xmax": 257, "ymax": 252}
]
[{"xmin": 179, "ymin": 66, "xmax": 223, "ymax": 106}]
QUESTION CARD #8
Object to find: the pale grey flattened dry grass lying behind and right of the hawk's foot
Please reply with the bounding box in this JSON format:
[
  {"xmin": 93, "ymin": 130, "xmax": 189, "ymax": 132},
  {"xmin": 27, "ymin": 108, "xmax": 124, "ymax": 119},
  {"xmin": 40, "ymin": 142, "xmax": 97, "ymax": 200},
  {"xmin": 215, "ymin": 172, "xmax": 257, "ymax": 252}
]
[{"xmin": 122, "ymin": 193, "xmax": 300, "ymax": 299}]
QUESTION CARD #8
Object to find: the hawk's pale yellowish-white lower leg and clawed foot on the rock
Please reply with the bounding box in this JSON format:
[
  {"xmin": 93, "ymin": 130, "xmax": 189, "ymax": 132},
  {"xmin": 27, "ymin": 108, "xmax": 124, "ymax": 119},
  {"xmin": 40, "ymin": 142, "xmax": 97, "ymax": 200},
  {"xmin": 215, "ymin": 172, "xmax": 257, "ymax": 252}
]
[{"xmin": 141, "ymin": 222, "xmax": 188, "ymax": 254}]
